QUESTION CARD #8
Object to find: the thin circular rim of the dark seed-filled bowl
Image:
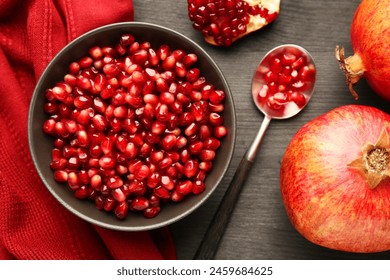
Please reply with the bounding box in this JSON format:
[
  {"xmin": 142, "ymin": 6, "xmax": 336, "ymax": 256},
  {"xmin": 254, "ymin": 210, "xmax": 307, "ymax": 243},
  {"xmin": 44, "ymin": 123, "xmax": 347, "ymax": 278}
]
[{"xmin": 27, "ymin": 21, "xmax": 237, "ymax": 231}]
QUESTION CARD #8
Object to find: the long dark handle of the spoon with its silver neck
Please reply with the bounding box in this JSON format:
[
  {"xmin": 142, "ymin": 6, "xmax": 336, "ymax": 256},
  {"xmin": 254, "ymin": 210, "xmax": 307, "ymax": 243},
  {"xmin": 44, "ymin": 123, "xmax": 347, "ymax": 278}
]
[{"xmin": 194, "ymin": 116, "xmax": 271, "ymax": 260}]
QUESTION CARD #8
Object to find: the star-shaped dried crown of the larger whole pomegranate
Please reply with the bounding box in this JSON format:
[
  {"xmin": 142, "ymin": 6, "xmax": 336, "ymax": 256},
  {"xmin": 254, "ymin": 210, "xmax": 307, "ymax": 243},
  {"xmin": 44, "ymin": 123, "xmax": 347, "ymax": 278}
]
[{"xmin": 348, "ymin": 129, "xmax": 390, "ymax": 189}]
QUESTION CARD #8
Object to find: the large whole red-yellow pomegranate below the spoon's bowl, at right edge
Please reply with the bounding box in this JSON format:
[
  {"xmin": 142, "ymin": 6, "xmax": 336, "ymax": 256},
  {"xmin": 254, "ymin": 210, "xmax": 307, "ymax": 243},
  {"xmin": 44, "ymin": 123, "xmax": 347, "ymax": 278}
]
[{"xmin": 280, "ymin": 105, "xmax": 390, "ymax": 253}]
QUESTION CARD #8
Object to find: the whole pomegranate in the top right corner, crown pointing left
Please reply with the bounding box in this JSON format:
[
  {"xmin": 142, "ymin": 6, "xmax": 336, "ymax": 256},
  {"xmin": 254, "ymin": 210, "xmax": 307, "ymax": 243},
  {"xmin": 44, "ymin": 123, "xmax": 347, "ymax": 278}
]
[{"xmin": 336, "ymin": 0, "xmax": 390, "ymax": 101}]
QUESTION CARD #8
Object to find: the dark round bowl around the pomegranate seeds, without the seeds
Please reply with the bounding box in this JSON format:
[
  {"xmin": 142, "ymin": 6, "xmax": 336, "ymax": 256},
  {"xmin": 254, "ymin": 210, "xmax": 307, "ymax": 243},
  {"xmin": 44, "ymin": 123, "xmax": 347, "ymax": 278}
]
[{"xmin": 28, "ymin": 22, "xmax": 236, "ymax": 231}]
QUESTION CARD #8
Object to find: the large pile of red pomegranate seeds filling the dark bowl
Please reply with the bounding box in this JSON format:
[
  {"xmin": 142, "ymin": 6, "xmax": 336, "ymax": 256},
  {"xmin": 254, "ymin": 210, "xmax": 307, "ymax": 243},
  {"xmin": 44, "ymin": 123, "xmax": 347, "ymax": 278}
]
[{"xmin": 43, "ymin": 34, "xmax": 227, "ymax": 219}]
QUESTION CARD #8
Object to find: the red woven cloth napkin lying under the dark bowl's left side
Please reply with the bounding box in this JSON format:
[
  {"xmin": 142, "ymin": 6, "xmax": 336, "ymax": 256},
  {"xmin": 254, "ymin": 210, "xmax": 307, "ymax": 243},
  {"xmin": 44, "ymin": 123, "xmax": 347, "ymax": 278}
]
[{"xmin": 0, "ymin": 0, "xmax": 176, "ymax": 260}]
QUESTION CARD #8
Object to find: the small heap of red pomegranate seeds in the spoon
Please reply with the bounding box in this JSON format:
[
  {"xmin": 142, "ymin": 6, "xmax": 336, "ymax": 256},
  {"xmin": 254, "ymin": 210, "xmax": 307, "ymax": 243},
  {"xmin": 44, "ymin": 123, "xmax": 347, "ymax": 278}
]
[{"xmin": 258, "ymin": 49, "xmax": 316, "ymax": 112}]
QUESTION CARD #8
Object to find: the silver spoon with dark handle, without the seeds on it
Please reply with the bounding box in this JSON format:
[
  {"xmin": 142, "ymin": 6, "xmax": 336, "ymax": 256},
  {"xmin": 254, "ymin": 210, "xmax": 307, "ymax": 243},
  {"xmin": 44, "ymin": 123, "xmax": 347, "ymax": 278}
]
[{"xmin": 194, "ymin": 44, "xmax": 315, "ymax": 260}]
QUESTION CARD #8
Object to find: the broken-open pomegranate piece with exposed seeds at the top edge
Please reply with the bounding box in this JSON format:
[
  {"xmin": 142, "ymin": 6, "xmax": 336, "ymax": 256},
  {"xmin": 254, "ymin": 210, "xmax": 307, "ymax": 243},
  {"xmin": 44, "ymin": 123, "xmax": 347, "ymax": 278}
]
[{"xmin": 187, "ymin": 0, "xmax": 280, "ymax": 47}]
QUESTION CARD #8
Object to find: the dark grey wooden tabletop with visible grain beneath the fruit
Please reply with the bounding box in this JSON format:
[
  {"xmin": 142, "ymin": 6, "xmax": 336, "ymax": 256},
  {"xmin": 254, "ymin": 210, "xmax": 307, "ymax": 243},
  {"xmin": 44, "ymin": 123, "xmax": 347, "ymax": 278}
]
[{"xmin": 133, "ymin": 0, "xmax": 390, "ymax": 260}]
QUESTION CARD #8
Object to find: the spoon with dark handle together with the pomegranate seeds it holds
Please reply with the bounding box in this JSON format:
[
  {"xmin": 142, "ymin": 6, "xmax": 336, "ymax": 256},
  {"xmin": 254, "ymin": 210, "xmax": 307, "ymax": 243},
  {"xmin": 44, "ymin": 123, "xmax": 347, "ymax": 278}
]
[{"xmin": 194, "ymin": 44, "xmax": 315, "ymax": 259}]
